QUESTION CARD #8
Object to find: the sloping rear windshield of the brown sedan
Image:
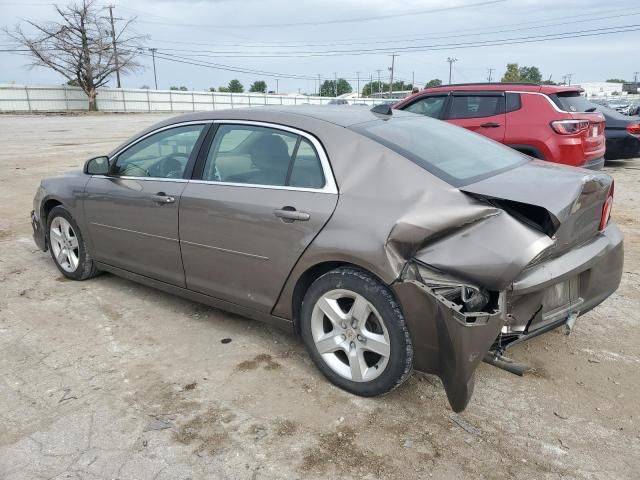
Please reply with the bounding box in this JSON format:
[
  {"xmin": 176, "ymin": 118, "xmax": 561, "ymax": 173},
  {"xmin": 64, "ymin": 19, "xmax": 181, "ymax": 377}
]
[{"xmin": 350, "ymin": 116, "xmax": 529, "ymax": 187}]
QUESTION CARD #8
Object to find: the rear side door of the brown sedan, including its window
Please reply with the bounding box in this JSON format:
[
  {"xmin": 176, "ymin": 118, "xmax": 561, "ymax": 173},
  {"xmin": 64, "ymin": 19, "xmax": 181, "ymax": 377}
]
[{"xmin": 180, "ymin": 122, "xmax": 338, "ymax": 312}]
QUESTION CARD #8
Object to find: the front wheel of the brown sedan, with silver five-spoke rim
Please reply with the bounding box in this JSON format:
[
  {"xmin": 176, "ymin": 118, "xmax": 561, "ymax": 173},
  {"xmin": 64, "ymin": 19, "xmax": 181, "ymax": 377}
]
[{"xmin": 47, "ymin": 206, "xmax": 99, "ymax": 280}]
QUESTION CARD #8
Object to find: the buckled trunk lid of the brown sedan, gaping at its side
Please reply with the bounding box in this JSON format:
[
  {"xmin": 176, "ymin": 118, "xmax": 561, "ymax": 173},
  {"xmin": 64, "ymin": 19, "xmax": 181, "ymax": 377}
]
[{"xmin": 460, "ymin": 160, "xmax": 613, "ymax": 253}]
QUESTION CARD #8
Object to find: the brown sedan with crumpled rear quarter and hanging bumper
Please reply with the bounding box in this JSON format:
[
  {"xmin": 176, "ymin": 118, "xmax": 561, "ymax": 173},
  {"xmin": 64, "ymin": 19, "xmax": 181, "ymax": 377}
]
[{"xmin": 31, "ymin": 105, "xmax": 623, "ymax": 411}]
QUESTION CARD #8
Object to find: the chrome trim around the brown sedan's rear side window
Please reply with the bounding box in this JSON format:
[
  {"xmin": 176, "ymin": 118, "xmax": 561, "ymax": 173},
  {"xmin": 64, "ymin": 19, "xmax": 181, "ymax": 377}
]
[{"xmin": 202, "ymin": 119, "xmax": 338, "ymax": 194}]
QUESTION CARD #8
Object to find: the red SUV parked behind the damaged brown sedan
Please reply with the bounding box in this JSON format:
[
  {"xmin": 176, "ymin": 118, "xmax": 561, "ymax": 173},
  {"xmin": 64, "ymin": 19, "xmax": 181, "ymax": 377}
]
[{"xmin": 393, "ymin": 83, "xmax": 605, "ymax": 170}]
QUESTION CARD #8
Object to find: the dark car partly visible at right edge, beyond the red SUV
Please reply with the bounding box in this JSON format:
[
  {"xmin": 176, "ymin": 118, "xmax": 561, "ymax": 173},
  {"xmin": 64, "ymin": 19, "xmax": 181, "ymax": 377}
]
[{"xmin": 598, "ymin": 106, "xmax": 640, "ymax": 160}]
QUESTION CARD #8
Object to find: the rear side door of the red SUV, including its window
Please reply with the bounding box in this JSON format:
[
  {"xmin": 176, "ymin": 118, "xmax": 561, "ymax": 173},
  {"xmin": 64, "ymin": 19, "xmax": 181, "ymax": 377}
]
[{"xmin": 444, "ymin": 92, "xmax": 506, "ymax": 142}]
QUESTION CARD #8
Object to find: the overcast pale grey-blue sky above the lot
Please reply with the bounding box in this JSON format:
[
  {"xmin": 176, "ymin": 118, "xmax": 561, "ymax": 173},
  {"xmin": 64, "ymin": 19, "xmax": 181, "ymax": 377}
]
[{"xmin": 0, "ymin": 0, "xmax": 640, "ymax": 92}]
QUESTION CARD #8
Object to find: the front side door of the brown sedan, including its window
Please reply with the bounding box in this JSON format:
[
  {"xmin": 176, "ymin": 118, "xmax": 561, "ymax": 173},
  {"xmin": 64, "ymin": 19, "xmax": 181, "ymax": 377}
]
[{"xmin": 84, "ymin": 123, "xmax": 210, "ymax": 287}]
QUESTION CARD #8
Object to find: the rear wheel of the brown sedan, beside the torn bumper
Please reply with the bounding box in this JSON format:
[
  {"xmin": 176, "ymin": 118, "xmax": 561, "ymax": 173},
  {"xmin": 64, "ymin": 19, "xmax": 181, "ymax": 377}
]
[{"xmin": 300, "ymin": 267, "xmax": 413, "ymax": 397}]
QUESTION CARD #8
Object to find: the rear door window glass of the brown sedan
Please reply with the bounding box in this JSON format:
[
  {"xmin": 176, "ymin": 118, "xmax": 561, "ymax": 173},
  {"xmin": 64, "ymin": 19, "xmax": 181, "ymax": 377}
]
[{"xmin": 202, "ymin": 125, "xmax": 325, "ymax": 188}]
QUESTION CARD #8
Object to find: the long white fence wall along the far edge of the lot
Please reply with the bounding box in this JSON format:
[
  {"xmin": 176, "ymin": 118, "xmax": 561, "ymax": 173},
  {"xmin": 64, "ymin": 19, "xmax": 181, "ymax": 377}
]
[{"xmin": 0, "ymin": 85, "xmax": 382, "ymax": 112}]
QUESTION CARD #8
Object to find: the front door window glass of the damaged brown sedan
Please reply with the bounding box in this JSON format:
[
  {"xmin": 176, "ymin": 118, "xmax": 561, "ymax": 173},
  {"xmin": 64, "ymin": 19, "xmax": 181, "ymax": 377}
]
[{"xmin": 112, "ymin": 125, "xmax": 205, "ymax": 178}]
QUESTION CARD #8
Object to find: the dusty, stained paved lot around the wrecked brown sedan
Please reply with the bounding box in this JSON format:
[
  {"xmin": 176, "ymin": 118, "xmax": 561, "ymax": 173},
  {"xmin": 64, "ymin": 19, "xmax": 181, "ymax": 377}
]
[{"xmin": 0, "ymin": 115, "xmax": 640, "ymax": 480}]
